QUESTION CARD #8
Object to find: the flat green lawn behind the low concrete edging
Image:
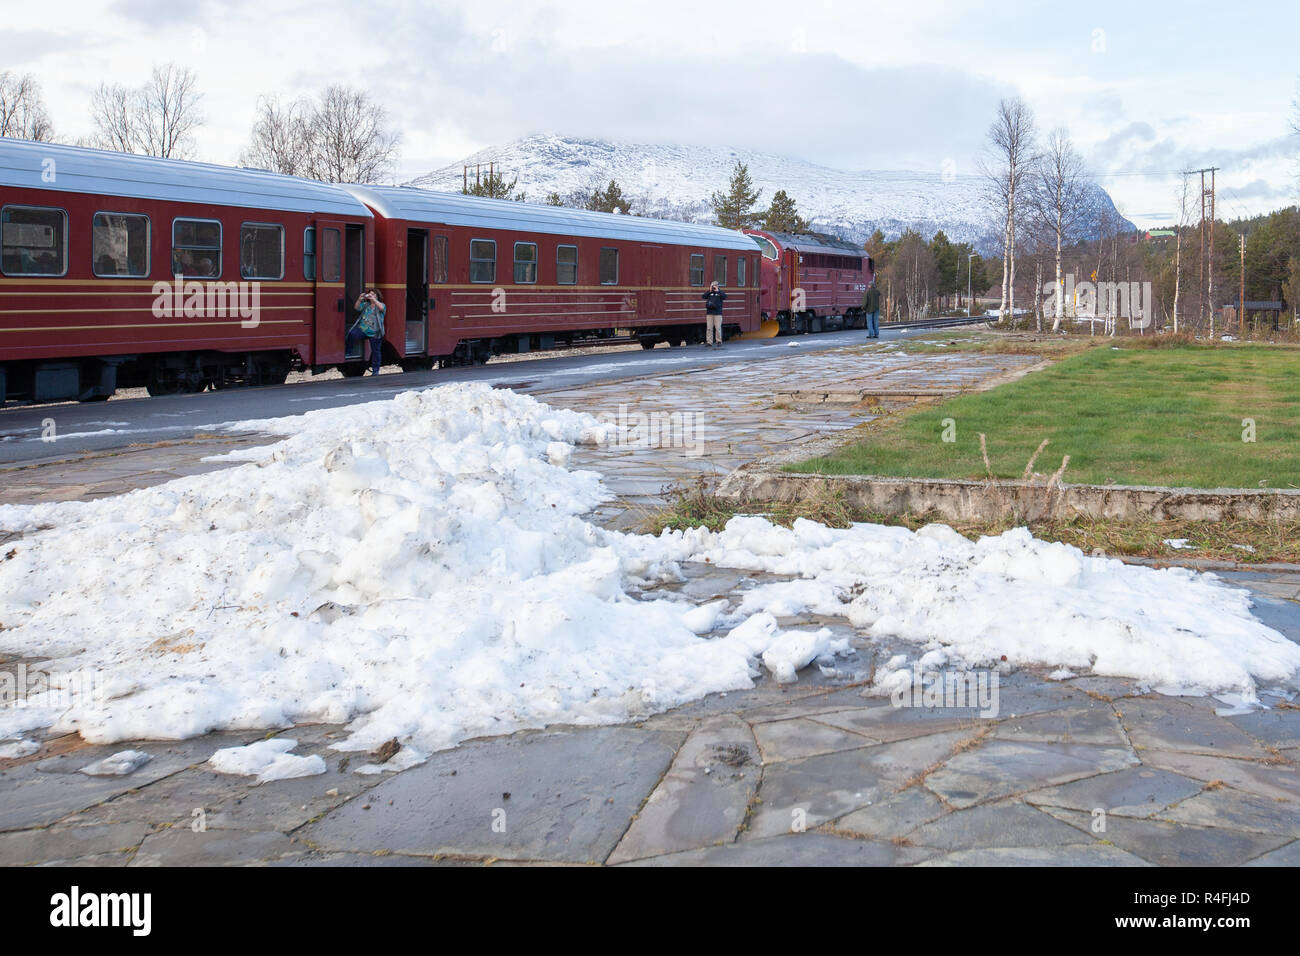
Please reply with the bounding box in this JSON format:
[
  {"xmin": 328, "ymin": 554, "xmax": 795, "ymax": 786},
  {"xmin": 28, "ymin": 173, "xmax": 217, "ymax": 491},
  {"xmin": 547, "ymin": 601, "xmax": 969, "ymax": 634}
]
[{"xmin": 787, "ymin": 343, "xmax": 1300, "ymax": 488}]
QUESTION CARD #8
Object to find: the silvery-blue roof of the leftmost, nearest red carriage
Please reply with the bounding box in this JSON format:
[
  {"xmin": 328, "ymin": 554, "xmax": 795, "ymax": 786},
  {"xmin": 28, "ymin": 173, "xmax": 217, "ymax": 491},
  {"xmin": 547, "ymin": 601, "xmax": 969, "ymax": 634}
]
[{"xmin": 0, "ymin": 139, "xmax": 371, "ymax": 219}]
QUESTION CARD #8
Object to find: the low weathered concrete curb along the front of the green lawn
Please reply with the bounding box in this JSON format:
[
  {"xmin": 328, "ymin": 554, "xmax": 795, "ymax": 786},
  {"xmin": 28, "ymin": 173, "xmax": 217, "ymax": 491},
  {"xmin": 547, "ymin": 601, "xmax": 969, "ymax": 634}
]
[{"xmin": 718, "ymin": 466, "xmax": 1300, "ymax": 522}]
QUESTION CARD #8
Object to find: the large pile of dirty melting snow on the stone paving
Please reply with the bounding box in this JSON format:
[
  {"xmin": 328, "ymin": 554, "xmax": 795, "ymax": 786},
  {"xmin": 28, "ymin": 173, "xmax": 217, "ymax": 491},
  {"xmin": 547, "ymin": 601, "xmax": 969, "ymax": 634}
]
[{"xmin": 0, "ymin": 384, "xmax": 1300, "ymax": 777}]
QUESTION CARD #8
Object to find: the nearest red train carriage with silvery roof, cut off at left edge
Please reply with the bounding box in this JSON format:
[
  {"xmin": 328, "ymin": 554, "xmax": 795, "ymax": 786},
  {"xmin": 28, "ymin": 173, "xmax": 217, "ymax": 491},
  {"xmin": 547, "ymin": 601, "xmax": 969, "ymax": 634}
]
[{"xmin": 0, "ymin": 139, "xmax": 374, "ymax": 402}]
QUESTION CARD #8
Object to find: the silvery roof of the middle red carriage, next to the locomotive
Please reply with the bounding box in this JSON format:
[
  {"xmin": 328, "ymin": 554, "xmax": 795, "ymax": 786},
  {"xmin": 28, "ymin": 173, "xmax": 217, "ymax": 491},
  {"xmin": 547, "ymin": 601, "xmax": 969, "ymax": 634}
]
[{"xmin": 346, "ymin": 186, "xmax": 754, "ymax": 252}]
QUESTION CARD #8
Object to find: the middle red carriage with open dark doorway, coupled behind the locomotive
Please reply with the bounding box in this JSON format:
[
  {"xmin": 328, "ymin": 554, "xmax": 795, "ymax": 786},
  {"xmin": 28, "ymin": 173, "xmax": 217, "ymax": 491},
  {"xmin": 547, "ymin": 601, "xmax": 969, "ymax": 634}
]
[{"xmin": 346, "ymin": 186, "xmax": 759, "ymax": 367}]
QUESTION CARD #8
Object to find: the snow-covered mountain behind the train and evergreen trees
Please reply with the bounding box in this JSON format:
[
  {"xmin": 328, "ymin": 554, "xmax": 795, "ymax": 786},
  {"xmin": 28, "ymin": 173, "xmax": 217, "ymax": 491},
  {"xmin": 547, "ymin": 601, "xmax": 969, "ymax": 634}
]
[{"xmin": 408, "ymin": 135, "xmax": 1132, "ymax": 245}]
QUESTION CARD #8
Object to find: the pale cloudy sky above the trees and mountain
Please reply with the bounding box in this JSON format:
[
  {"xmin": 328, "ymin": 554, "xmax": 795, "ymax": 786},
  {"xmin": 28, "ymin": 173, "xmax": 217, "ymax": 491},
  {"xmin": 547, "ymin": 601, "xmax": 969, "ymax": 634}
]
[{"xmin": 10, "ymin": 0, "xmax": 1300, "ymax": 226}]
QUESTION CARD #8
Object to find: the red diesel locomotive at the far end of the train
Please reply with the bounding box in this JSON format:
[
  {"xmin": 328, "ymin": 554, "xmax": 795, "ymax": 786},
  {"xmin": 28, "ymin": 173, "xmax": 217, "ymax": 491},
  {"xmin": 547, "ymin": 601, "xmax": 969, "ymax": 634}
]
[{"xmin": 745, "ymin": 229, "xmax": 875, "ymax": 334}]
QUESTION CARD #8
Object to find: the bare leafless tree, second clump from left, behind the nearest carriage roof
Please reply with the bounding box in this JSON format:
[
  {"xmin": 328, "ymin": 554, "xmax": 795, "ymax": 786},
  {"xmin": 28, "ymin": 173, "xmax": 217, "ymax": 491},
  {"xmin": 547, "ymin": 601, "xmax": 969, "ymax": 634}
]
[{"xmin": 91, "ymin": 62, "xmax": 204, "ymax": 159}]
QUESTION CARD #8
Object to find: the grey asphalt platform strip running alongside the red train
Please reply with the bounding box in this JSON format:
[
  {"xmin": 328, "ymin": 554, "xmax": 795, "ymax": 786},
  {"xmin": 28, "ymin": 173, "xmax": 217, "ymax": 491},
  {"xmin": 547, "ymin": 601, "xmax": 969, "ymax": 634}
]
[{"xmin": 0, "ymin": 329, "xmax": 922, "ymax": 466}]
